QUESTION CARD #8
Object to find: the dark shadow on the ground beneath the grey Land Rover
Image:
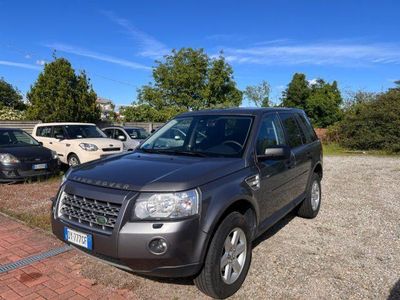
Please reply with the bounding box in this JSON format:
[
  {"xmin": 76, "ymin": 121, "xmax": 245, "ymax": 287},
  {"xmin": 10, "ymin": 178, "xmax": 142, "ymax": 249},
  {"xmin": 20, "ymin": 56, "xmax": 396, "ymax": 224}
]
[{"xmin": 126, "ymin": 212, "xmax": 296, "ymax": 284}]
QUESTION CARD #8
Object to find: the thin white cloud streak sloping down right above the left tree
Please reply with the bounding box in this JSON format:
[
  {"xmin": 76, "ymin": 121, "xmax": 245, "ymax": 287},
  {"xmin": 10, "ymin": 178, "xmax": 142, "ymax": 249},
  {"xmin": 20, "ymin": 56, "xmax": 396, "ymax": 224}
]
[{"xmin": 45, "ymin": 43, "xmax": 151, "ymax": 70}]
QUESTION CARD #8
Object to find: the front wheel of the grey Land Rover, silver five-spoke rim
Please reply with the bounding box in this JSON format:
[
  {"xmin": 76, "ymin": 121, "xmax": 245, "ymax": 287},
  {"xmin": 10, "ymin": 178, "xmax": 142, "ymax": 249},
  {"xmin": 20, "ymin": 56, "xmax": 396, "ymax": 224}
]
[{"xmin": 194, "ymin": 212, "xmax": 251, "ymax": 299}]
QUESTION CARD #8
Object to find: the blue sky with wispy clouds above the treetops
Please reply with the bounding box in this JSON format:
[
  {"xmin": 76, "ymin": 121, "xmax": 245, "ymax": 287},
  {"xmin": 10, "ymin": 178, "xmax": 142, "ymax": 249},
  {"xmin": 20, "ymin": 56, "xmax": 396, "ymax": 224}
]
[{"xmin": 0, "ymin": 0, "xmax": 400, "ymax": 106}]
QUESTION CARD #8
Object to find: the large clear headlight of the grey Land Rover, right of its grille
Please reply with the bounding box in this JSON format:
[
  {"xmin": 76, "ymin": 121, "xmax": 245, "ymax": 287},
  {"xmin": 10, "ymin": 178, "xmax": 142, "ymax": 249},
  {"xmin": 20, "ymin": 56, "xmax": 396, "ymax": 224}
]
[{"xmin": 133, "ymin": 190, "xmax": 199, "ymax": 219}]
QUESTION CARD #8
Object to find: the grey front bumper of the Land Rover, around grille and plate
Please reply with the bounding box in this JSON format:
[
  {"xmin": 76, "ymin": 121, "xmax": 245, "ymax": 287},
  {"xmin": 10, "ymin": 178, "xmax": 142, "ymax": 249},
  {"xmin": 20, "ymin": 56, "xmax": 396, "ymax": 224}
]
[{"xmin": 51, "ymin": 182, "xmax": 208, "ymax": 277}]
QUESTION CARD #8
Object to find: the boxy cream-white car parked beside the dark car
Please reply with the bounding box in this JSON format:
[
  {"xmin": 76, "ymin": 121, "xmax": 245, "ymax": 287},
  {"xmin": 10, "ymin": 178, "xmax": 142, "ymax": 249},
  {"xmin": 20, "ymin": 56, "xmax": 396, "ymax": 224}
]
[{"xmin": 32, "ymin": 123, "xmax": 123, "ymax": 166}]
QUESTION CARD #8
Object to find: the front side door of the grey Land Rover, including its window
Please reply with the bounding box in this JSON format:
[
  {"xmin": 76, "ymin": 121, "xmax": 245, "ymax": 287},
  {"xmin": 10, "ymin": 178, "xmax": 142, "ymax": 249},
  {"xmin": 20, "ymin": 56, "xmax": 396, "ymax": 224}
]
[{"xmin": 255, "ymin": 113, "xmax": 293, "ymax": 220}]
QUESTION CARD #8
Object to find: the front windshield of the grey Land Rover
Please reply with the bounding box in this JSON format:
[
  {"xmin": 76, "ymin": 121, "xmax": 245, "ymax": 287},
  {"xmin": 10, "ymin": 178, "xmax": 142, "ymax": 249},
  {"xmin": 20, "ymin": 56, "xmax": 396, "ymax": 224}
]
[{"xmin": 139, "ymin": 115, "xmax": 252, "ymax": 157}]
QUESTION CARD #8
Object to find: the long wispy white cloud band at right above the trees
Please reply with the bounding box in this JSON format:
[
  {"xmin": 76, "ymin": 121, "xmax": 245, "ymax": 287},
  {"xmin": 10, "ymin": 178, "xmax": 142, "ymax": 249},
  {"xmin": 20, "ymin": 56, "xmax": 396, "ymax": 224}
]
[{"xmin": 223, "ymin": 41, "xmax": 400, "ymax": 66}]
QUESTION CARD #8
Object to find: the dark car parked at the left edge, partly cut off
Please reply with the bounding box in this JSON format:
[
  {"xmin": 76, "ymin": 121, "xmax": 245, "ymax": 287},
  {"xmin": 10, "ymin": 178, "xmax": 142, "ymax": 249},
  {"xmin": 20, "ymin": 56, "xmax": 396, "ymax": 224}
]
[{"xmin": 0, "ymin": 128, "xmax": 60, "ymax": 182}]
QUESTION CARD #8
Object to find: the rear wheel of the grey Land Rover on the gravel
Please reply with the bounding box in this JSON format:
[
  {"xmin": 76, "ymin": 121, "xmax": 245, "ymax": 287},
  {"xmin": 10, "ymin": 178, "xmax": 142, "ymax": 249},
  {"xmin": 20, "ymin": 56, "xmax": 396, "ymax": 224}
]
[{"xmin": 297, "ymin": 173, "xmax": 321, "ymax": 219}]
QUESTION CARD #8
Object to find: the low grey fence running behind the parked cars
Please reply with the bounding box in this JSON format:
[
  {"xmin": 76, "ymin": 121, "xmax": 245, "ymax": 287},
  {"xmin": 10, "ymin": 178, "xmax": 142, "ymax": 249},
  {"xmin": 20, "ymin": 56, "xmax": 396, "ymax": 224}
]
[{"xmin": 0, "ymin": 120, "xmax": 164, "ymax": 134}]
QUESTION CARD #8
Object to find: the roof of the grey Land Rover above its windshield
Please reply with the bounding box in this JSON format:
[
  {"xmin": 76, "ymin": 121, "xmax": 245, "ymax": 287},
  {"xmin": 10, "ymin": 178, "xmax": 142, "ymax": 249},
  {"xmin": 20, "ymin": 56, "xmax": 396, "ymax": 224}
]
[{"xmin": 179, "ymin": 107, "xmax": 302, "ymax": 117}]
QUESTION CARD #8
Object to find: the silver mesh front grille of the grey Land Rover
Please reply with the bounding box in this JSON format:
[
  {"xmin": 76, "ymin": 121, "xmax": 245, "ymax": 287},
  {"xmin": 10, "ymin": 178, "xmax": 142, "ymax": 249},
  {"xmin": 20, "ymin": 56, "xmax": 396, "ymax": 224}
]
[{"xmin": 60, "ymin": 193, "xmax": 121, "ymax": 233}]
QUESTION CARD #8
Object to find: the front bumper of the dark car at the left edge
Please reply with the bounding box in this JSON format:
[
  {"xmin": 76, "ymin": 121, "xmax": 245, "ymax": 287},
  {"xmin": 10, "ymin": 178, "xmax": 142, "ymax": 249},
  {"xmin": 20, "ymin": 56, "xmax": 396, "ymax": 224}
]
[{"xmin": 0, "ymin": 159, "xmax": 60, "ymax": 182}]
